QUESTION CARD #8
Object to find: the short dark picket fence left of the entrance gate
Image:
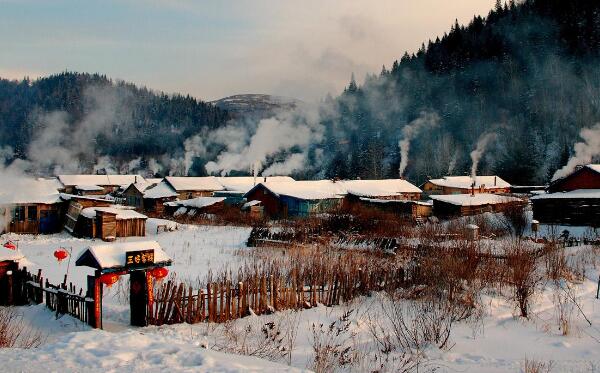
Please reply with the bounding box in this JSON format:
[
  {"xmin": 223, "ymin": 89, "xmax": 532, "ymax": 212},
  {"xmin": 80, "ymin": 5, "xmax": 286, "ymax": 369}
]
[{"xmin": 20, "ymin": 268, "xmax": 94, "ymax": 325}]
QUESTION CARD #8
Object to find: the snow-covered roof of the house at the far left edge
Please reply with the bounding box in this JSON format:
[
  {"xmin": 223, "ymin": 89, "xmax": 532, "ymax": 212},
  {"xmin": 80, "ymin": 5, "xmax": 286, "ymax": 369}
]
[{"xmin": 0, "ymin": 177, "xmax": 61, "ymax": 204}]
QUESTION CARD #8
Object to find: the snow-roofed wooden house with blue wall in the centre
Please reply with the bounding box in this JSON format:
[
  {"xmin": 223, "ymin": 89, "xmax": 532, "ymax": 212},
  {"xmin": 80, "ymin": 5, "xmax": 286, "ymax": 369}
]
[{"xmin": 244, "ymin": 180, "xmax": 346, "ymax": 218}]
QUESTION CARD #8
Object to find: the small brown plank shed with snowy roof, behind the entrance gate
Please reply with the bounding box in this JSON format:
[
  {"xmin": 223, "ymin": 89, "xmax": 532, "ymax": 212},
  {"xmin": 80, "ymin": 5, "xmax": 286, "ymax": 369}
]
[{"xmin": 73, "ymin": 205, "xmax": 148, "ymax": 240}]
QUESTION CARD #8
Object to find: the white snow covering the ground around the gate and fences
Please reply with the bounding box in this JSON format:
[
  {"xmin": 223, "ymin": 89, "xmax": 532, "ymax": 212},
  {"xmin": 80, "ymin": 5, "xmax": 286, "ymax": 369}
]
[{"xmin": 0, "ymin": 220, "xmax": 600, "ymax": 372}]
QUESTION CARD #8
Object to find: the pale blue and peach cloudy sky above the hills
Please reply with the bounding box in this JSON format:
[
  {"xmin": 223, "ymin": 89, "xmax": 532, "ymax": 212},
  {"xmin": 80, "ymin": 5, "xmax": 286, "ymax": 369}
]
[{"xmin": 0, "ymin": 0, "xmax": 495, "ymax": 101}]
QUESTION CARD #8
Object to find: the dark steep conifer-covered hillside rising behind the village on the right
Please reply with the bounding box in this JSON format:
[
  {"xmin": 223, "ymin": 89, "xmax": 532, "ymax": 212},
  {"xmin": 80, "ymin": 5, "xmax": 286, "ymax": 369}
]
[{"xmin": 324, "ymin": 0, "xmax": 600, "ymax": 184}]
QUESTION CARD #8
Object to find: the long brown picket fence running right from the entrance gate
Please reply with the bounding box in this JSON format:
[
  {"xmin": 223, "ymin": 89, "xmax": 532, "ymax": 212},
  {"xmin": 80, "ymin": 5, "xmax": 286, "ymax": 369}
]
[{"xmin": 149, "ymin": 266, "xmax": 407, "ymax": 325}]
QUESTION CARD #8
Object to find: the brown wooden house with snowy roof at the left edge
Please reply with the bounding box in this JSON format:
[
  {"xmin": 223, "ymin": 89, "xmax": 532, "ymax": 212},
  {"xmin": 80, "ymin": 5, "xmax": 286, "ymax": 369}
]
[{"xmin": 0, "ymin": 179, "xmax": 64, "ymax": 234}]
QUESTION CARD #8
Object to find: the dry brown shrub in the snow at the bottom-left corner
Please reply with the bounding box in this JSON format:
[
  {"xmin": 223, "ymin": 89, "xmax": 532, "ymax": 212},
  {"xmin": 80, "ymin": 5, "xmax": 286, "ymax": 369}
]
[{"xmin": 0, "ymin": 307, "xmax": 45, "ymax": 348}]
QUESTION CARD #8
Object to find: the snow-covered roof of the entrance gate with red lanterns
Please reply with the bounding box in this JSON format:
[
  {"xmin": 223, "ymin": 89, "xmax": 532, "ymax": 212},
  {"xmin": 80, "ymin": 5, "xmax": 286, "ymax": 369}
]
[{"xmin": 76, "ymin": 241, "xmax": 171, "ymax": 269}]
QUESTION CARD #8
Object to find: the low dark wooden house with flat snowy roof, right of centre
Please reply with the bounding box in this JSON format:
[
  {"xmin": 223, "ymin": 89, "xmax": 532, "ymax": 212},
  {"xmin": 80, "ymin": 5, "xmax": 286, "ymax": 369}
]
[{"xmin": 431, "ymin": 193, "xmax": 526, "ymax": 218}]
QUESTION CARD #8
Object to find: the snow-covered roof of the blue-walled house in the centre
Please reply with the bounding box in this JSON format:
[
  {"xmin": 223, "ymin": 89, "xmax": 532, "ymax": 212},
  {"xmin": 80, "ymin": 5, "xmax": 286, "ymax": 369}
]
[{"xmin": 253, "ymin": 180, "xmax": 346, "ymax": 200}]
